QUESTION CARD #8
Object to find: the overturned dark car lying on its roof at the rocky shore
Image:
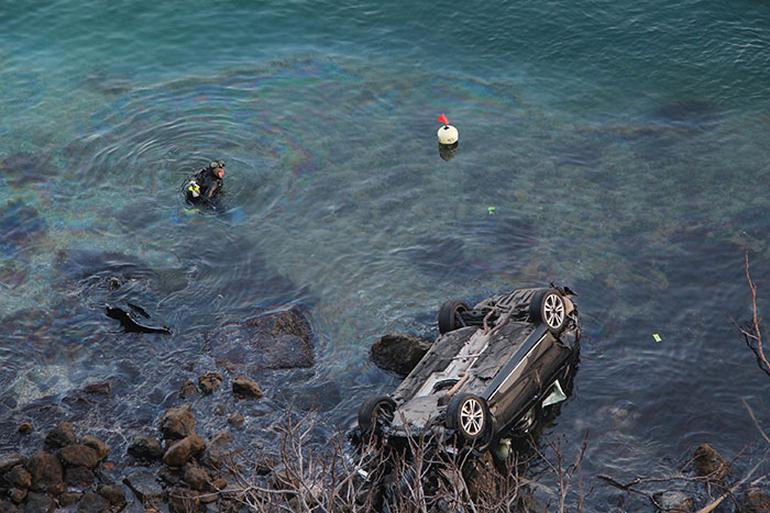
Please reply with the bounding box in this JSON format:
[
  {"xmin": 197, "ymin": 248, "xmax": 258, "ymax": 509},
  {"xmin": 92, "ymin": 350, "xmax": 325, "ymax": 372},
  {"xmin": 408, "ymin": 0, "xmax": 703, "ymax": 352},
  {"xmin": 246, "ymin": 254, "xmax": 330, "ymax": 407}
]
[{"xmin": 358, "ymin": 287, "xmax": 580, "ymax": 448}]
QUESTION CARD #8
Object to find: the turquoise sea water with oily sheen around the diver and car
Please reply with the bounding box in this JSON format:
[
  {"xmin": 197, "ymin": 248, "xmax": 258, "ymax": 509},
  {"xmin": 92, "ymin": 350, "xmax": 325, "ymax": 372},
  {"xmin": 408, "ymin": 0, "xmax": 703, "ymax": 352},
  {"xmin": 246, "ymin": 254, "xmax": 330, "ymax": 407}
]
[{"xmin": 0, "ymin": 1, "xmax": 770, "ymax": 504}]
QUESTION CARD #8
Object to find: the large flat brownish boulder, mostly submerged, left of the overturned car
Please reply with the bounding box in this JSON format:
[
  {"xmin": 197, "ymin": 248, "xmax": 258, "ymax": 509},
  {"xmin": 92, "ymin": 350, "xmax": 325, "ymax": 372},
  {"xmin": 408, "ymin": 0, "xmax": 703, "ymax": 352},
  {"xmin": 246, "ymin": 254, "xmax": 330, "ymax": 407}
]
[{"xmin": 204, "ymin": 307, "xmax": 315, "ymax": 373}]
